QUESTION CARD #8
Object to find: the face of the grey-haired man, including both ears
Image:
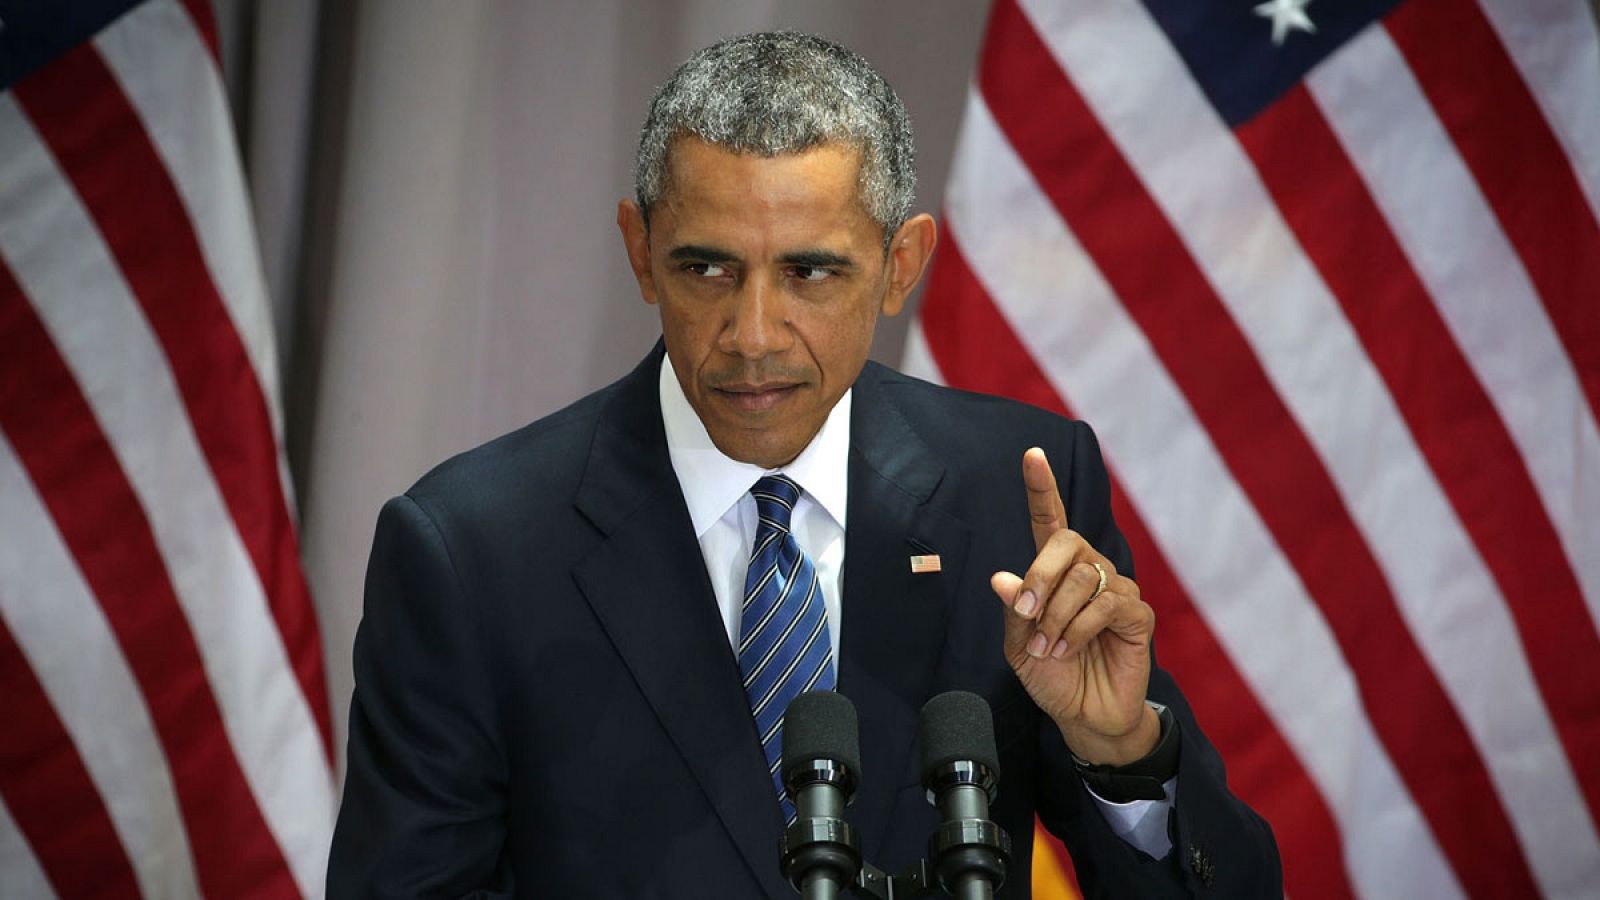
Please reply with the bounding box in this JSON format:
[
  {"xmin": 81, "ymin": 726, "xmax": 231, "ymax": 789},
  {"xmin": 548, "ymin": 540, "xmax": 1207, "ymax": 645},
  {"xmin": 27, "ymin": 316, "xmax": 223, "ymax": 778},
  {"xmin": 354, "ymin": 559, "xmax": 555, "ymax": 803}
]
[{"xmin": 618, "ymin": 138, "xmax": 933, "ymax": 468}]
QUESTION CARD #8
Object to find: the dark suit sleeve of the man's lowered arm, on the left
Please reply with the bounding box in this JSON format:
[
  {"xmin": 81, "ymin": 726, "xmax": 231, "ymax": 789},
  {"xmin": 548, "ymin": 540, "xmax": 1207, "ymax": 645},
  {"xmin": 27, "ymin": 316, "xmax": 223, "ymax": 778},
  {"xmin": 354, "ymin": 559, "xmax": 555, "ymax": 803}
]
[{"xmin": 328, "ymin": 496, "xmax": 507, "ymax": 898}]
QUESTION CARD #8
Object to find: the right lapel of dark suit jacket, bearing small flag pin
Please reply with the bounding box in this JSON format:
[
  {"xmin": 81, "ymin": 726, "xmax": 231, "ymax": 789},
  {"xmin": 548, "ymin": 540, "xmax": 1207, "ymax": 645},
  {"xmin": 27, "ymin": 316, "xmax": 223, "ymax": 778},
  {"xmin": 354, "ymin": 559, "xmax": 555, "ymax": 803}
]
[{"xmin": 838, "ymin": 364, "xmax": 968, "ymax": 858}]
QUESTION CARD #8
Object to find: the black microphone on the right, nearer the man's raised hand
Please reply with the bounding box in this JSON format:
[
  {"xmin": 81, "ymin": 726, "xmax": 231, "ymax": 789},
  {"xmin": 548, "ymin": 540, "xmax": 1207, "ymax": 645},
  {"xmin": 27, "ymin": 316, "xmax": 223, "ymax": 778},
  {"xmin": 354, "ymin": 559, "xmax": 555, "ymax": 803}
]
[{"xmin": 922, "ymin": 690, "xmax": 1011, "ymax": 900}]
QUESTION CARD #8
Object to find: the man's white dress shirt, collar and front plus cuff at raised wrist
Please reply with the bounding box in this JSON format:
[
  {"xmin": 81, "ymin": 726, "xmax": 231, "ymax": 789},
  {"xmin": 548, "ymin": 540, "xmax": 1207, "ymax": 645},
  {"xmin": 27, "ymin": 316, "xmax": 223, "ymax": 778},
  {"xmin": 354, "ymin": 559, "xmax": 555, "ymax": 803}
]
[{"xmin": 661, "ymin": 354, "xmax": 1178, "ymax": 858}]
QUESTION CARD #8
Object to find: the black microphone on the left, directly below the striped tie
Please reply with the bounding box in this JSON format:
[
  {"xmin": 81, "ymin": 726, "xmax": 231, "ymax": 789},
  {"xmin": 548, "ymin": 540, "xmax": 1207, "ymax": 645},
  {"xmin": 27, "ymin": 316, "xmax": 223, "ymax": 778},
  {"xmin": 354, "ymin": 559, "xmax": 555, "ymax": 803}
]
[{"xmin": 778, "ymin": 690, "xmax": 861, "ymax": 900}]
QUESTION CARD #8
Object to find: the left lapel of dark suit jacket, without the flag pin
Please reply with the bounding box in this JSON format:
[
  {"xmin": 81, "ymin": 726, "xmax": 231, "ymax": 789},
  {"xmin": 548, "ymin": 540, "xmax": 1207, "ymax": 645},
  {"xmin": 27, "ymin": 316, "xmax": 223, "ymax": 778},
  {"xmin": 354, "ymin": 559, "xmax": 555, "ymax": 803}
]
[{"xmin": 574, "ymin": 346, "xmax": 782, "ymax": 886}]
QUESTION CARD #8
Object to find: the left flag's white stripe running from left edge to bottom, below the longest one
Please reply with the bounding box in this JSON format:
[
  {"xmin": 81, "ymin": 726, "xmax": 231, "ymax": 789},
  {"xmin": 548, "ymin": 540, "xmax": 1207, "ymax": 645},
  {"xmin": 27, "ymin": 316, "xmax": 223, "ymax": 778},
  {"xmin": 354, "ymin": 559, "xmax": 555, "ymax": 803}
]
[{"xmin": 0, "ymin": 436, "xmax": 200, "ymax": 898}]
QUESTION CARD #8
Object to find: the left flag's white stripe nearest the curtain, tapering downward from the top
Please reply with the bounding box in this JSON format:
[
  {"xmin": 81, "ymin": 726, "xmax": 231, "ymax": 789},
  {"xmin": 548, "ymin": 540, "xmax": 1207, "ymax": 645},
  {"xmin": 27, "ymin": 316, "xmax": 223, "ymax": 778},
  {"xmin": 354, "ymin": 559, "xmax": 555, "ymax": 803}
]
[{"xmin": 94, "ymin": 0, "xmax": 294, "ymax": 501}]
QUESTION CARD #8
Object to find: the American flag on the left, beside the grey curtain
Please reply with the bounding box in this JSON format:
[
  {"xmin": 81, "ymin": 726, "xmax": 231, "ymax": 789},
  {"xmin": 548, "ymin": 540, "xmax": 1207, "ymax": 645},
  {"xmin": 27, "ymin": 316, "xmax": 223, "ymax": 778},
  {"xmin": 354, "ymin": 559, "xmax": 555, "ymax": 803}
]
[{"xmin": 0, "ymin": 0, "xmax": 334, "ymax": 898}]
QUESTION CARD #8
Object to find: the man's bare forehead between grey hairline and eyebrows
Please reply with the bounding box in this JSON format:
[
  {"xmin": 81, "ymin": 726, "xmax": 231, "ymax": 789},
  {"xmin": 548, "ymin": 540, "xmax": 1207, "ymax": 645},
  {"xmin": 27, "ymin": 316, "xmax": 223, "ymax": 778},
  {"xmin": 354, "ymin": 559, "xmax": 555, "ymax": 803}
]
[{"xmin": 659, "ymin": 138, "xmax": 877, "ymax": 240}]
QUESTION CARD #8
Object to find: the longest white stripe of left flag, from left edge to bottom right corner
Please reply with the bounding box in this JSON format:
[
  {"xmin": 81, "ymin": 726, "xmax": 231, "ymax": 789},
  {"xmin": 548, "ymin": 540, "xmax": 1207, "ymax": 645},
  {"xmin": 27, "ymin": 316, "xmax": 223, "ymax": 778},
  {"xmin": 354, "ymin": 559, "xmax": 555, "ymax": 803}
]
[{"xmin": 0, "ymin": 96, "xmax": 334, "ymax": 895}]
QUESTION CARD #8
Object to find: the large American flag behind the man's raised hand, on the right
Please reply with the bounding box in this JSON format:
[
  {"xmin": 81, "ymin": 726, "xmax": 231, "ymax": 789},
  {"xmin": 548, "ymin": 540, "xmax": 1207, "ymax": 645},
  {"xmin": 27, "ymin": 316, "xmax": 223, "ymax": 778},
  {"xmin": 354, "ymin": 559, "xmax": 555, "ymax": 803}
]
[{"xmin": 907, "ymin": 0, "xmax": 1600, "ymax": 898}]
